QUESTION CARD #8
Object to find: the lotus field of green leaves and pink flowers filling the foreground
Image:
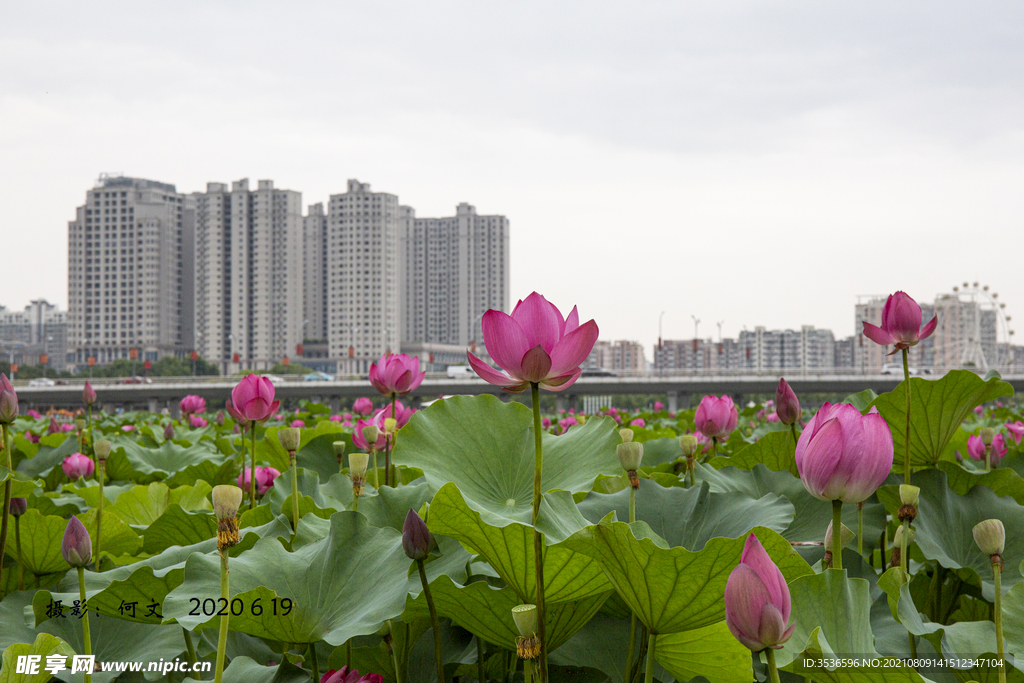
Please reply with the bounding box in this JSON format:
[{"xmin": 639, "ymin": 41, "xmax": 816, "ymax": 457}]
[{"xmin": 0, "ymin": 292, "xmax": 1024, "ymax": 683}]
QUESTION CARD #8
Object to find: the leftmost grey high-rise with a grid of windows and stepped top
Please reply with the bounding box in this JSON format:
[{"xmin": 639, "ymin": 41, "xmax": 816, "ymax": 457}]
[{"xmin": 68, "ymin": 176, "xmax": 193, "ymax": 365}]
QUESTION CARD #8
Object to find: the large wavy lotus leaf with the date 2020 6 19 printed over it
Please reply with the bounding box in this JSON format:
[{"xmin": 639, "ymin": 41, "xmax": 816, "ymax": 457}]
[{"xmin": 164, "ymin": 512, "xmax": 410, "ymax": 645}]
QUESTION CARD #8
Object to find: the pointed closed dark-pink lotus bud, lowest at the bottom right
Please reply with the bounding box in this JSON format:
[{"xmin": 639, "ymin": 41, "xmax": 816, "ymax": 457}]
[{"xmin": 725, "ymin": 533, "xmax": 796, "ymax": 652}]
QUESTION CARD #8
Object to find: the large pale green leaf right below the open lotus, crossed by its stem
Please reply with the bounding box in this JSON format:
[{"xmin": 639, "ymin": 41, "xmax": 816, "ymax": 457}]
[{"xmin": 394, "ymin": 395, "xmax": 622, "ymax": 523}]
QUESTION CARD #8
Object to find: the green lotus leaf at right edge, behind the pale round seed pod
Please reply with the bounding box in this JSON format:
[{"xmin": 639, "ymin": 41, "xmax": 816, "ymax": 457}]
[{"xmin": 878, "ymin": 470, "xmax": 1024, "ymax": 600}]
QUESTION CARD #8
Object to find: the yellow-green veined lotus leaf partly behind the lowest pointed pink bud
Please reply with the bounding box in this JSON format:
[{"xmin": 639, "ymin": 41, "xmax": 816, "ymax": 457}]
[{"xmin": 563, "ymin": 518, "xmax": 811, "ymax": 634}]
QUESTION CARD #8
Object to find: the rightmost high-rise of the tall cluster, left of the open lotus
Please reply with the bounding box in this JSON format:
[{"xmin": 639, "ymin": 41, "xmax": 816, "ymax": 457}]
[{"xmin": 399, "ymin": 203, "xmax": 510, "ymax": 346}]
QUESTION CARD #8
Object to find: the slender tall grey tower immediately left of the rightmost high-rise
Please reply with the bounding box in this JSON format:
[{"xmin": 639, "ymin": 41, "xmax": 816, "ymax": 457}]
[{"xmin": 325, "ymin": 179, "xmax": 401, "ymax": 374}]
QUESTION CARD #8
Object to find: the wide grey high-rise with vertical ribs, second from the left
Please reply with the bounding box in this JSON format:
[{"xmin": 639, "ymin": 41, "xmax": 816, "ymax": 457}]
[{"xmin": 191, "ymin": 178, "xmax": 304, "ymax": 373}]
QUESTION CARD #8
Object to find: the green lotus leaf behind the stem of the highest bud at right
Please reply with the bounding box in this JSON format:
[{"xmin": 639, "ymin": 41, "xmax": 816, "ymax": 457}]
[{"xmin": 871, "ymin": 370, "xmax": 1014, "ymax": 471}]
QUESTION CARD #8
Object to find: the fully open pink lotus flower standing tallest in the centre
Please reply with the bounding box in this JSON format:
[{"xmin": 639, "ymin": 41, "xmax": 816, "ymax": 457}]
[{"xmin": 466, "ymin": 292, "xmax": 598, "ymax": 393}]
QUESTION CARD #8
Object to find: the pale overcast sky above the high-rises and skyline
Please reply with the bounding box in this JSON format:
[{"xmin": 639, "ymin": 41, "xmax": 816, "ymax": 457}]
[{"xmin": 0, "ymin": 0, "xmax": 1024, "ymax": 352}]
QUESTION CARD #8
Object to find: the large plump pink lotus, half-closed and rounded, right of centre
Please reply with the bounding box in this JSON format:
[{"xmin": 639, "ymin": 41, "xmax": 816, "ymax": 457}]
[{"xmin": 796, "ymin": 402, "xmax": 893, "ymax": 503}]
